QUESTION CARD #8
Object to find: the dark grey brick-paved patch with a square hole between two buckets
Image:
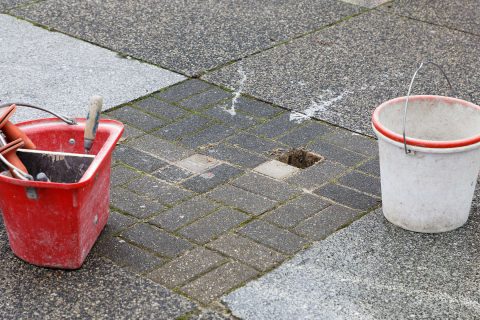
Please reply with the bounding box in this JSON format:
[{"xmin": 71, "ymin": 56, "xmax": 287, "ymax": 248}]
[{"xmin": 95, "ymin": 79, "xmax": 380, "ymax": 305}]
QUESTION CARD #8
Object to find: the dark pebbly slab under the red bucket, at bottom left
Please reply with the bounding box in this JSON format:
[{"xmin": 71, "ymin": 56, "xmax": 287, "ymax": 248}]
[{"xmin": 0, "ymin": 226, "xmax": 196, "ymax": 319}]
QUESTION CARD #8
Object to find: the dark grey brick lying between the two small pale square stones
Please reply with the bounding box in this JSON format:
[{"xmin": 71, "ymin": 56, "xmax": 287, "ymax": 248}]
[{"xmin": 205, "ymin": 143, "xmax": 266, "ymax": 168}]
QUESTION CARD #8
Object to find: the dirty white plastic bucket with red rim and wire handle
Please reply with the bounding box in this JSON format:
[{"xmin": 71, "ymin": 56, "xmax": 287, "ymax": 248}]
[{"xmin": 372, "ymin": 96, "xmax": 480, "ymax": 232}]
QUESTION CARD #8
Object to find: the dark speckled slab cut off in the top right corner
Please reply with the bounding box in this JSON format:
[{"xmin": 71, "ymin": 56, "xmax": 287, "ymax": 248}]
[{"xmin": 381, "ymin": 0, "xmax": 480, "ymax": 35}]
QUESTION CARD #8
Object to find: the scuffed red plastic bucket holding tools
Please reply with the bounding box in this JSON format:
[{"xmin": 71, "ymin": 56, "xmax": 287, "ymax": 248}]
[{"xmin": 0, "ymin": 119, "xmax": 123, "ymax": 269}]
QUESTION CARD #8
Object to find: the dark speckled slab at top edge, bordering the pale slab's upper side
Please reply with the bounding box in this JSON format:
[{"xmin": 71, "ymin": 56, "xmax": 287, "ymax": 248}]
[{"xmin": 13, "ymin": 0, "xmax": 362, "ymax": 75}]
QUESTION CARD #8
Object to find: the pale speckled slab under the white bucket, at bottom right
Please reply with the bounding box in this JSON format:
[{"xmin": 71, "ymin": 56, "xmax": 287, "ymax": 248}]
[{"xmin": 224, "ymin": 204, "xmax": 480, "ymax": 319}]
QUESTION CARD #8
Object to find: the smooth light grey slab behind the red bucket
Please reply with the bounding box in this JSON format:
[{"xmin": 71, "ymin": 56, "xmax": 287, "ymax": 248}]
[{"xmin": 0, "ymin": 15, "xmax": 184, "ymax": 120}]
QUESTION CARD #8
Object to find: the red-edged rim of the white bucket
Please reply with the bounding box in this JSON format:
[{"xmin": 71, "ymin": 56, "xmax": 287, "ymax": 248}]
[{"xmin": 372, "ymin": 95, "xmax": 480, "ymax": 148}]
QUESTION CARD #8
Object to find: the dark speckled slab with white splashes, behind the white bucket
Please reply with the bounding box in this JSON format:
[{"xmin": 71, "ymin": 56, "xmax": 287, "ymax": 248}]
[{"xmin": 203, "ymin": 10, "xmax": 480, "ymax": 134}]
